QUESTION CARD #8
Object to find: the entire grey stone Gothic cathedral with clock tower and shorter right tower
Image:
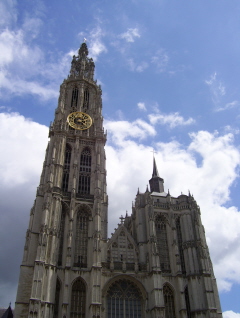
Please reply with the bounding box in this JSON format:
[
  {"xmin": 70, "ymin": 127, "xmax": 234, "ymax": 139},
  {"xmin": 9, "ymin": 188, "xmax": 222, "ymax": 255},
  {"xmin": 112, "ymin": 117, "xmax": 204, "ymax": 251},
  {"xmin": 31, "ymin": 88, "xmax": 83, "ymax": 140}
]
[{"xmin": 14, "ymin": 43, "xmax": 222, "ymax": 318}]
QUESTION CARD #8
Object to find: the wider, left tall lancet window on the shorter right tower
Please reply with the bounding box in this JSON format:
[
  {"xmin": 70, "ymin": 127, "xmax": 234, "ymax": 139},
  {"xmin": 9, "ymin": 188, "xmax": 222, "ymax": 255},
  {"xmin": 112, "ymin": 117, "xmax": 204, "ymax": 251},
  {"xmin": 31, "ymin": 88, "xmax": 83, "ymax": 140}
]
[{"xmin": 155, "ymin": 216, "xmax": 171, "ymax": 272}]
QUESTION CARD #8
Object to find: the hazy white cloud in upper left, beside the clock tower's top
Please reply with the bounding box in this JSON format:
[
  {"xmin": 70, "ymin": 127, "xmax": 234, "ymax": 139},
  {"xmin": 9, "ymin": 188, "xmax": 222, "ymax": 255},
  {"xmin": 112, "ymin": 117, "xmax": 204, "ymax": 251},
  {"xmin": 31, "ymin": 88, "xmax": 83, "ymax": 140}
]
[{"xmin": 0, "ymin": 24, "xmax": 74, "ymax": 100}]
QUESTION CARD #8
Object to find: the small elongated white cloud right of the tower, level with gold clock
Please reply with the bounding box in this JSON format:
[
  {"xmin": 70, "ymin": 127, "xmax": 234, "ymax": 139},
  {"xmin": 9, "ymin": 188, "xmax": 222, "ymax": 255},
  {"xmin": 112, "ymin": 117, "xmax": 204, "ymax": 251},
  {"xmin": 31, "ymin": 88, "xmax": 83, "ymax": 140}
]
[{"xmin": 148, "ymin": 112, "xmax": 195, "ymax": 128}]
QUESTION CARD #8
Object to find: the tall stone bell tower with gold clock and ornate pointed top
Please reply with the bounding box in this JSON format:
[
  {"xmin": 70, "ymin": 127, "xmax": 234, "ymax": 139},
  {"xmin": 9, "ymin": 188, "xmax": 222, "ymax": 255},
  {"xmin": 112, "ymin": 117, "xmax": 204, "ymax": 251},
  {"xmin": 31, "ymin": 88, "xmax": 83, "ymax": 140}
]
[{"xmin": 15, "ymin": 43, "xmax": 108, "ymax": 318}]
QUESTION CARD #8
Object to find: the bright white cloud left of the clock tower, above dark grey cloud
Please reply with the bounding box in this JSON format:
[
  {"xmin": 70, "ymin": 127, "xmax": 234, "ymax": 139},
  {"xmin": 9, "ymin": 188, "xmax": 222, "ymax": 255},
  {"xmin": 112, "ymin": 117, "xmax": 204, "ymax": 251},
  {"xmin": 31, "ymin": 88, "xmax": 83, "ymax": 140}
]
[{"xmin": 0, "ymin": 113, "xmax": 48, "ymax": 187}]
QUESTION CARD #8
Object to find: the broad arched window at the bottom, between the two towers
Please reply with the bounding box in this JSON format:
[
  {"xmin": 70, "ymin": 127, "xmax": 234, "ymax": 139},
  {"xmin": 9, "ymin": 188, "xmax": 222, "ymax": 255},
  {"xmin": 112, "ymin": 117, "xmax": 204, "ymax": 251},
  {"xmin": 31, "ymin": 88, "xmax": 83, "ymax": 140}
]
[{"xmin": 107, "ymin": 279, "xmax": 143, "ymax": 318}]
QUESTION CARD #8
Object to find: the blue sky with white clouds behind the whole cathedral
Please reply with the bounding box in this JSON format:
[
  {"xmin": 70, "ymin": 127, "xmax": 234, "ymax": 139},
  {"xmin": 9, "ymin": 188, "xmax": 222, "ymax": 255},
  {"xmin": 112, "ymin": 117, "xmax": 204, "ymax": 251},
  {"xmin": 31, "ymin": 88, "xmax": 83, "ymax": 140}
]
[{"xmin": 0, "ymin": 0, "xmax": 240, "ymax": 318}]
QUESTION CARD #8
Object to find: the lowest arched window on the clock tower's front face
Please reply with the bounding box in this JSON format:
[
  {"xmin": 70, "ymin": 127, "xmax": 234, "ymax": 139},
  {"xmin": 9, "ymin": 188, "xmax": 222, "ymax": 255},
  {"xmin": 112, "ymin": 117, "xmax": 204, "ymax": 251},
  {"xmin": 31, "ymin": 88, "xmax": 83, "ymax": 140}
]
[{"xmin": 70, "ymin": 279, "xmax": 86, "ymax": 318}]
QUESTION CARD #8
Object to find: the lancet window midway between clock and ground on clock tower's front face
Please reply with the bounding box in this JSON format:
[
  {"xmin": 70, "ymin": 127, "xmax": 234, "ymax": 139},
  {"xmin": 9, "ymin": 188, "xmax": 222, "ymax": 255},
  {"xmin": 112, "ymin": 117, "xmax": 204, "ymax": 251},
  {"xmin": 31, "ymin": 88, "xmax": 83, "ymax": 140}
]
[{"xmin": 74, "ymin": 207, "xmax": 89, "ymax": 268}]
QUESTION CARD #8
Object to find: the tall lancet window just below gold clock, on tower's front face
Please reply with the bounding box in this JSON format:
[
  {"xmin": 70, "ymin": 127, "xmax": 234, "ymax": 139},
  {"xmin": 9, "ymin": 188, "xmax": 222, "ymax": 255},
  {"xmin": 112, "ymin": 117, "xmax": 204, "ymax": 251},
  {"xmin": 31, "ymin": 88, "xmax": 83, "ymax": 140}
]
[{"xmin": 78, "ymin": 148, "xmax": 92, "ymax": 194}]
